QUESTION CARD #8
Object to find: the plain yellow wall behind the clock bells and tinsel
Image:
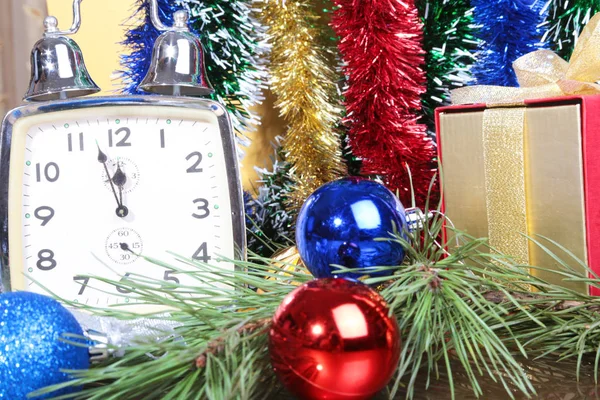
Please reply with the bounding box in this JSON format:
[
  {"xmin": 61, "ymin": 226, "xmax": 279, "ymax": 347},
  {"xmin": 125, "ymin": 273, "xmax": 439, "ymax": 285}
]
[{"xmin": 47, "ymin": 0, "xmax": 281, "ymax": 190}]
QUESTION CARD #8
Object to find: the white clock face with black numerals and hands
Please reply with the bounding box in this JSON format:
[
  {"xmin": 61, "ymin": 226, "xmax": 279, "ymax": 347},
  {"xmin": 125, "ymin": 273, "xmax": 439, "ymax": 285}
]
[{"xmin": 2, "ymin": 99, "xmax": 239, "ymax": 306}]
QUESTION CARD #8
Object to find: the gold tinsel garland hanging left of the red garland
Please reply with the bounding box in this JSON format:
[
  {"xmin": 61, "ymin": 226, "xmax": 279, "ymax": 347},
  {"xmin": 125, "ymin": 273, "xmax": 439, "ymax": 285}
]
[{"xmin": 262, "ymin": 0, "xmax": 344, "ymax": 208}]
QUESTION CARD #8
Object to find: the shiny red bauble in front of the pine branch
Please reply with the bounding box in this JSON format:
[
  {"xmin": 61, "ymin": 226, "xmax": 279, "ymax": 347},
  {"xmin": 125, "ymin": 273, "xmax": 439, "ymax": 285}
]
[{"xmin": 269, "ymin": 278, "xmax": 400, "ymax": 400}]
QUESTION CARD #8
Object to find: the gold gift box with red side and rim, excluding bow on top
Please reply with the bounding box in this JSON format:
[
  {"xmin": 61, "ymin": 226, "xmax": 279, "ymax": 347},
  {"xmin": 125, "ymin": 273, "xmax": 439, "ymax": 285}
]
[{"xmin": 436, "ymin": 95, "xmax": 600, "ymax": 295}]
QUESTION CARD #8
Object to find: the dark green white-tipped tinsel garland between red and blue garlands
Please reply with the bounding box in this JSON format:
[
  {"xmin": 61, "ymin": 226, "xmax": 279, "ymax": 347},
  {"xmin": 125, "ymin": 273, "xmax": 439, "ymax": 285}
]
[{"xmin": 416, "ymin": 0, "xmax": 477, "ymax": 135}]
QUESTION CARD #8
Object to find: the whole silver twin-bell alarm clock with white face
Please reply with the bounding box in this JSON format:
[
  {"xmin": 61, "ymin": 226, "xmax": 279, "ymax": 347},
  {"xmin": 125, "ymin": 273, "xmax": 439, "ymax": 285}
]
[{"xmin": 0, "ymin": 0, "xmax": 245, "ymax": 306}]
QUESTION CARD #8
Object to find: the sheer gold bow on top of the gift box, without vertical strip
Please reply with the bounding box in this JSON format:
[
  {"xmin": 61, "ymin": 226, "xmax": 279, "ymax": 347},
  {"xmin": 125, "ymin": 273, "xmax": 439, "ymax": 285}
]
[{"xmin": 452, "ymin": 13, "xmax": 600, "ymax": 104}]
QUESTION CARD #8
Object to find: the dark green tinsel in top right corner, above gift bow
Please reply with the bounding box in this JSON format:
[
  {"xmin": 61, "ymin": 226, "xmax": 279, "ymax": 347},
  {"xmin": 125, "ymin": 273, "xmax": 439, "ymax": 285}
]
[{"xmin": 545, "ymin": 0, "xmax": 600, "ymax": 60}]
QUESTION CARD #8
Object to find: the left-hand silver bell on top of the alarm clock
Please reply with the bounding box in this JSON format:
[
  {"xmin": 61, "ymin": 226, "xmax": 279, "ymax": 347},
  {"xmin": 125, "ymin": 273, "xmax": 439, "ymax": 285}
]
[{"xmin": 23, "ymin": 0, "xmax": 100, "ymax": 101}]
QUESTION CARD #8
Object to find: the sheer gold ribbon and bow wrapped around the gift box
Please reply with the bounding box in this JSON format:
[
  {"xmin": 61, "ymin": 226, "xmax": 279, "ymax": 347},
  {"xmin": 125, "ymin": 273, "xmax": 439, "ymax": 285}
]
[{"xmin": 452, "ymin": 13, "xmax": 600, "ymax": 264}]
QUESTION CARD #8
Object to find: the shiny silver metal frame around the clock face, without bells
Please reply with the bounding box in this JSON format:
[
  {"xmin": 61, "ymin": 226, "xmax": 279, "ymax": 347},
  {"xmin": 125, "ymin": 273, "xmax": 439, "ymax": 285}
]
[{"xmin": 0, "ymin": 96, "xmax": 246, "ymax": 293}]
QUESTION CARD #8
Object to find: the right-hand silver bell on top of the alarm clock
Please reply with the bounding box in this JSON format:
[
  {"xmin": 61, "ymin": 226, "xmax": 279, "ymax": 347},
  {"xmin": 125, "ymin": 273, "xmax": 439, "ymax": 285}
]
[{"xmin": 139, "ymin": 0, "xmax": 214, "ymax": 96}]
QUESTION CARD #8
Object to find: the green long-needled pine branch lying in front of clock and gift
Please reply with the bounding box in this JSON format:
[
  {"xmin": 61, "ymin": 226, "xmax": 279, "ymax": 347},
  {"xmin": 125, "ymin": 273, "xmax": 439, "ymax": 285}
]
[{"xmin": 32, "ymin": 214, "xmax": 600, "ymax": 400}]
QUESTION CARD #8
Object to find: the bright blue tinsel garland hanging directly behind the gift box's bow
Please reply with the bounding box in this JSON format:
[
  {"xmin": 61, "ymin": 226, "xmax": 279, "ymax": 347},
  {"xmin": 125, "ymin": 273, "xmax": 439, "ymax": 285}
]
[{"xmin": 471, "ymin": 0, "xmax": 547, "ymax": 86}]
